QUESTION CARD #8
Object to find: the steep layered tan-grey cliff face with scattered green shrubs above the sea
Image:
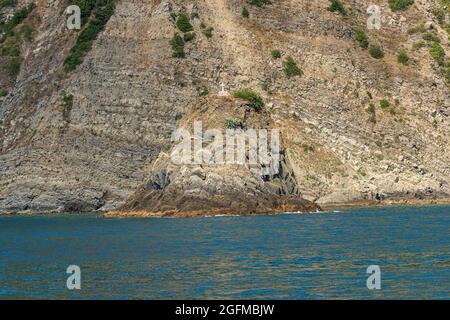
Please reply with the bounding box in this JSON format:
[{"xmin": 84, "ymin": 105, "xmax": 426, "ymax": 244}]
[{"xmin": 0, "ymin": 0, "xmax": 450, "ymax": 213}]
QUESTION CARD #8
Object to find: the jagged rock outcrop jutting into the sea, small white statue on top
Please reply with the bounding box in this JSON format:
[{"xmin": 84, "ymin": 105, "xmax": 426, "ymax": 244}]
[{"xmin": 106, "ymin": 97, "xmax": 321, "ymax": 217}]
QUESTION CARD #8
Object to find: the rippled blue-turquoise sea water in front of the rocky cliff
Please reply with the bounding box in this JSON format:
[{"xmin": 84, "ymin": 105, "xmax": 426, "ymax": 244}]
[{"xmin": 0, "ymin": 206, "xmax": 450, "ymax": 299}]
